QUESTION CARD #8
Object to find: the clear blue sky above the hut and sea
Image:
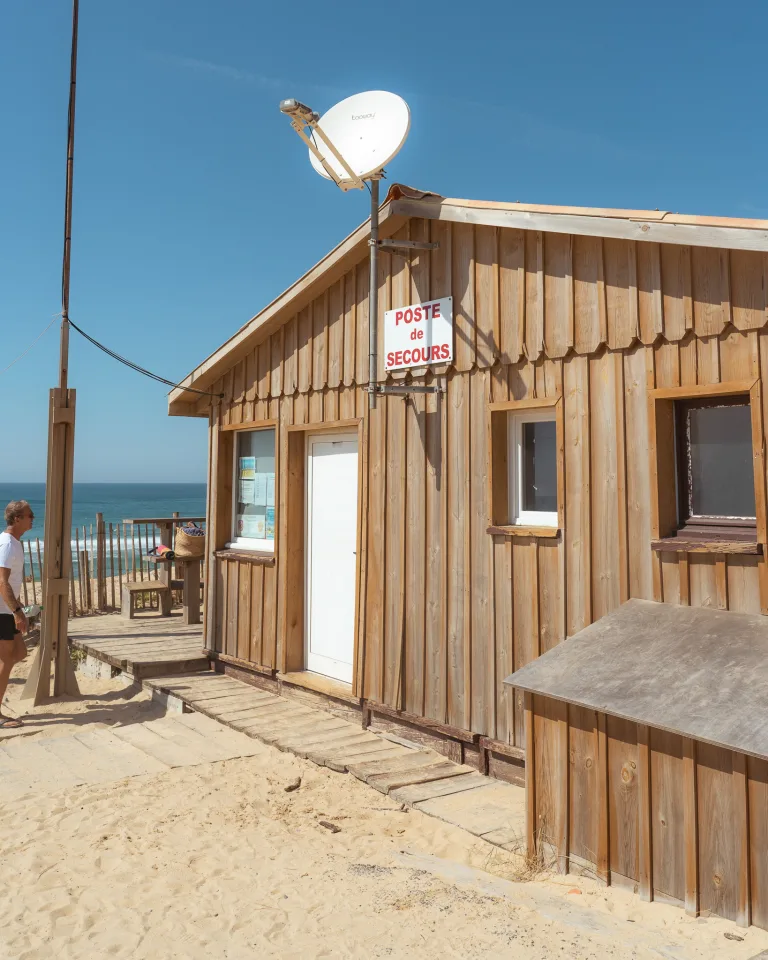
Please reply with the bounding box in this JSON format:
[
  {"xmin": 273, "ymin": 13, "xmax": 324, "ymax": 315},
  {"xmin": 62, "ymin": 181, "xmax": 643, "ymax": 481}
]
[{"xmin": 0, "ymin": 0, "xmax": 768, "ymax": 481}]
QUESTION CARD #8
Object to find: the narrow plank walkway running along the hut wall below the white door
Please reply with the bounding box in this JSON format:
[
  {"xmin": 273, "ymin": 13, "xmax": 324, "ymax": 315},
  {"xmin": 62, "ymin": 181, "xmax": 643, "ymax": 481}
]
[{"xmin": 144, "ymin": 672, "xmax": 525, "ymax": 851}]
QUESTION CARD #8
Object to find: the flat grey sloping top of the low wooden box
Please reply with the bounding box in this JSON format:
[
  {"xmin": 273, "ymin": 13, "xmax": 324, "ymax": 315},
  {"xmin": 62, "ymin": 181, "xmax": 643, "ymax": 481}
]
[{"xmin": 505, "ymin": 600, "xmax": 768, "ymax": 757}]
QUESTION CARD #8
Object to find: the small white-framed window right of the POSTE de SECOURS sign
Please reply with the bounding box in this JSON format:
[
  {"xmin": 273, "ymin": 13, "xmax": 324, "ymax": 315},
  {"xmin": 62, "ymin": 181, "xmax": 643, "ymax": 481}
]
[{"xmin": 507, "ymin": 409, "xmax": 557, "ymax": 527}]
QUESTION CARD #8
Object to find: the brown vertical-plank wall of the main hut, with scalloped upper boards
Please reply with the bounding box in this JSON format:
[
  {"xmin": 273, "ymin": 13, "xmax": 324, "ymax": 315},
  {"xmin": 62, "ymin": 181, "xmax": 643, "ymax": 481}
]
[{"xmin": 201, "ymin": 219, "xmax": 768, "ymax": 747}]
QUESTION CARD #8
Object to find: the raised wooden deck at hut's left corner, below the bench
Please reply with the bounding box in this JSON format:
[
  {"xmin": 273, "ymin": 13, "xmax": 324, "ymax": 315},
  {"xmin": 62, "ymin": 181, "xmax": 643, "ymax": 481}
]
[{"xmin": 68, "ymin": 611, "xmax": 208, "ymax": 680}]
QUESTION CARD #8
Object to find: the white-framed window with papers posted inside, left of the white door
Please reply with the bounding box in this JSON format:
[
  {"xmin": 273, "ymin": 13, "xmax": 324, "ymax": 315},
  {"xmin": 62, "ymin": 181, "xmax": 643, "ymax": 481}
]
[{"xmin": 232, "ymin": 429, "xmax": 275, "ymax": 551}]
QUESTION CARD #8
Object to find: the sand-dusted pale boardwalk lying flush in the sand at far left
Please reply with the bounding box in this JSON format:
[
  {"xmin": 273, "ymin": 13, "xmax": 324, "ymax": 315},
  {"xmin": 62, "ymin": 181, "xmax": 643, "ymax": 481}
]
[{"xmin": 0, "ymin": 713, "xmax": 262, "ymax": 802}]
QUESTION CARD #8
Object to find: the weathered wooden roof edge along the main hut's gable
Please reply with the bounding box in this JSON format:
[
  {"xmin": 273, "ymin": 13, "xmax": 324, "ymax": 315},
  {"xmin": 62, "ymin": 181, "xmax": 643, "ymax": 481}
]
[{"xmin": 168, "ymin": 184, "xmax": 768, "ymax": 416}]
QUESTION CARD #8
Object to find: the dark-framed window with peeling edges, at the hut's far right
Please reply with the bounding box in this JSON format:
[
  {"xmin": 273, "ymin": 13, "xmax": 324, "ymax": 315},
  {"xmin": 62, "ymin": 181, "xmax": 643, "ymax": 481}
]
[{"xmin": 675, "ymin": 395, "xmax": 756, "ymax": 540}]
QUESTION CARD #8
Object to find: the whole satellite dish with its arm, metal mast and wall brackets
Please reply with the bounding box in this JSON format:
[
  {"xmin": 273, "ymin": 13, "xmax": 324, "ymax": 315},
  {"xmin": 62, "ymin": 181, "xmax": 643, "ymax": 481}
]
[{"xmin": 280, "ymin": 90, "xmax": 441, "ymax": 409}]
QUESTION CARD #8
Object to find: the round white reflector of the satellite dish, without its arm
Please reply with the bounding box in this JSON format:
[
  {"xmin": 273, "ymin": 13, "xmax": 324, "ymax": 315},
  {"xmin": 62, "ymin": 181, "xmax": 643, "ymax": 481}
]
[{"xmin": 309, "ymin": 90, "xmax": 411, "ymax": 182}]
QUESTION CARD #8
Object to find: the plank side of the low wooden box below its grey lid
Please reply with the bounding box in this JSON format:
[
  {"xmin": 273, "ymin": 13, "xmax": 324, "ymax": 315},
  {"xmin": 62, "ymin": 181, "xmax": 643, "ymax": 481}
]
[{"xmin": 527, "ymin": 696, "xmax": 768, "ymax": 927}]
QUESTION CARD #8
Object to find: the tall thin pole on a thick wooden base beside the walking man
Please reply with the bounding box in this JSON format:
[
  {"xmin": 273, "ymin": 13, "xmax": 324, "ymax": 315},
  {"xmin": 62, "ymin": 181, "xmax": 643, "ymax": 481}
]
[{"xmin": 21, "ymin": 0, "xmax": 80, "ymax": 706}]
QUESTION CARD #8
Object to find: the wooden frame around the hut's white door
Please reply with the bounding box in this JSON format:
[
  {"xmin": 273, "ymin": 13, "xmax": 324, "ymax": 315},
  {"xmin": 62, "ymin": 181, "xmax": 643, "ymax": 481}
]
[{"xmin": 278, "ymin": 417, "xmax": 367, "ymax": 697}]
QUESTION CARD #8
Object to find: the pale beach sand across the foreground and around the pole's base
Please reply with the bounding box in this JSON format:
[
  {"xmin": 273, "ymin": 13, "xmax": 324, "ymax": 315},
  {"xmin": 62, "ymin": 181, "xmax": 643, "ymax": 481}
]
[{"xmin": 0, "ymin": 658, "xmax": 768, "ymax": 960}]
